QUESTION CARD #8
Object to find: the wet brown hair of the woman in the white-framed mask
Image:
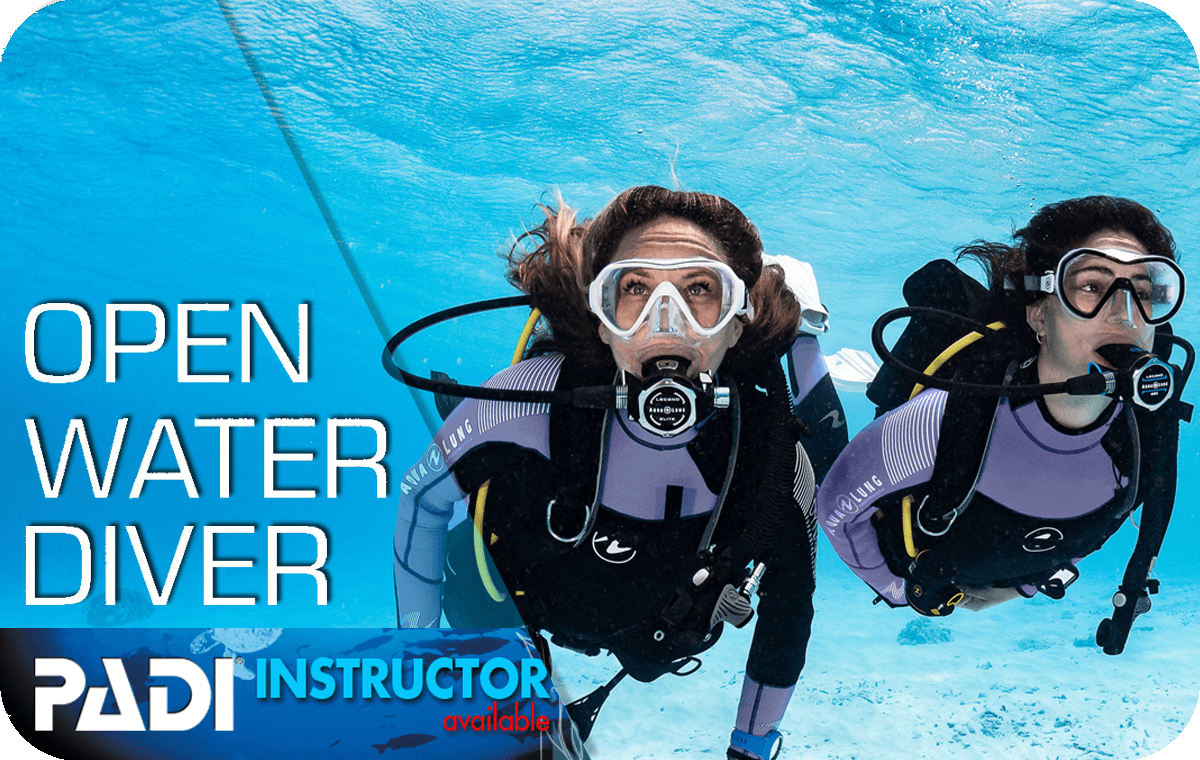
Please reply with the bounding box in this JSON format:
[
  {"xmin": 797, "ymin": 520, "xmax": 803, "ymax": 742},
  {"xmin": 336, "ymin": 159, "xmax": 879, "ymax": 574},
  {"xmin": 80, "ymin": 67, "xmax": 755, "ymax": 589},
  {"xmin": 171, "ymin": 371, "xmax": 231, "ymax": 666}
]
[{"xmin": 509, "ymin": 185, "xmax": 800, "ymax": 374}]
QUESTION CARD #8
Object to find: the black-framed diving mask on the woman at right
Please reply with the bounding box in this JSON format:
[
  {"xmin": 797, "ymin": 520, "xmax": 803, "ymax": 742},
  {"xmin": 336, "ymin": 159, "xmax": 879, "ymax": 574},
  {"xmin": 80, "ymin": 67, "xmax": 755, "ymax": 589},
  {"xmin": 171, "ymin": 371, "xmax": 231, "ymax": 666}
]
[{"xmin": 1025, "ymin": 249, "xmax": 1184, "ymax": 324}]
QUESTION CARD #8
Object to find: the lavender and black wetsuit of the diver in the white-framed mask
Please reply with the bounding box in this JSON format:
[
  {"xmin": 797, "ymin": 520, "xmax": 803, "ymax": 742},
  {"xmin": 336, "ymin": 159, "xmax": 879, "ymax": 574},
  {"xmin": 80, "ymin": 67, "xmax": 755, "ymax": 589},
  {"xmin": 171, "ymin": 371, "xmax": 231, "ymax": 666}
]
[{"xmin": 394, "ymin": 335, "xmax": 846, "ymax": 735}]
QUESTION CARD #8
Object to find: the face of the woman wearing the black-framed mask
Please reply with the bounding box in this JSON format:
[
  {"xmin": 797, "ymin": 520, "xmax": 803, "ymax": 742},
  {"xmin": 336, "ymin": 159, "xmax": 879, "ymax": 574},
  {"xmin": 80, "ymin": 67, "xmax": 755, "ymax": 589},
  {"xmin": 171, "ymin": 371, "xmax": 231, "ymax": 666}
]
[{"xmin": 1026, "ymin": 229, "xmax": 1154, "ymax": 382}]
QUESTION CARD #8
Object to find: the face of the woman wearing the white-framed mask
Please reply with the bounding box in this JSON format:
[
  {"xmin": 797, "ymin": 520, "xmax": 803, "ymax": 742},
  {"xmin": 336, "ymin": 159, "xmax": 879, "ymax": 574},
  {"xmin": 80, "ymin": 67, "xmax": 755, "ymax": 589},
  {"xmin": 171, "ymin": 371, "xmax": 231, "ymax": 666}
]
[{"xmin": 600, "ymin": 216, "xmax": 743, "ymax": 377}]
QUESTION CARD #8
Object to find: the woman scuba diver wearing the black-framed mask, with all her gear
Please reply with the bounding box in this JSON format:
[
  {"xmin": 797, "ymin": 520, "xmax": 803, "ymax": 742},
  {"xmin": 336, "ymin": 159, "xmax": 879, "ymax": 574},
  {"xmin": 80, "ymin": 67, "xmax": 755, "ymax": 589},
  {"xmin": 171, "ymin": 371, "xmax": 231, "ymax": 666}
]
[{"xmin": 817, "ymin": 196, "xmax": 1194, "ymax": 654}]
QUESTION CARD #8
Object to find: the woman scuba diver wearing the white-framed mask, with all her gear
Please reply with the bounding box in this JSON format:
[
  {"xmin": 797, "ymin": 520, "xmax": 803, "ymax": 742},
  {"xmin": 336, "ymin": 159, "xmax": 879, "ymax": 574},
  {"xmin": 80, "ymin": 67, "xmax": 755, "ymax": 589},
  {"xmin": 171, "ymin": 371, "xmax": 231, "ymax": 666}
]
[{"xmin": 384, "ymin": 186, "xmax": 847, "ymax": 760}]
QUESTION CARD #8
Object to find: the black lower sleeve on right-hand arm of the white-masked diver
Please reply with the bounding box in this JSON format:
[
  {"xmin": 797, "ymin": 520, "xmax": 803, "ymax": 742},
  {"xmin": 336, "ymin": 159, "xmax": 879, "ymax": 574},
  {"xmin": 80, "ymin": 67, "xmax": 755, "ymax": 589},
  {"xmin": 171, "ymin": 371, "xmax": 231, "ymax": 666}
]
[{"xmin": 746, "ymin": 439, "xmax": 817, "ymax": 688}]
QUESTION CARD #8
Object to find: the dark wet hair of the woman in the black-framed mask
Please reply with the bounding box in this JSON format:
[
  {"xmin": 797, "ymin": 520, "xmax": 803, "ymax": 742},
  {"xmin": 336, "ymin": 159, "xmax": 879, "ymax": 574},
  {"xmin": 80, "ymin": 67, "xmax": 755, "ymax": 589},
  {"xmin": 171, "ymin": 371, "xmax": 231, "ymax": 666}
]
[{"xmin": 958, "ymin": 196, "xmax": 1176, "ymax": 297}]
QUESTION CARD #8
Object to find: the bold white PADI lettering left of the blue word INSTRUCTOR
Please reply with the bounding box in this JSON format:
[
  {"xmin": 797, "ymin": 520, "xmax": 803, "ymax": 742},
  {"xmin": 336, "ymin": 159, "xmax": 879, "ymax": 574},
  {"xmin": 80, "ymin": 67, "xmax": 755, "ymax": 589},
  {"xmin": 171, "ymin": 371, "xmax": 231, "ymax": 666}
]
[{"xmin": 34, "ymin": 657, "xmax": 234, "ymax": 731}]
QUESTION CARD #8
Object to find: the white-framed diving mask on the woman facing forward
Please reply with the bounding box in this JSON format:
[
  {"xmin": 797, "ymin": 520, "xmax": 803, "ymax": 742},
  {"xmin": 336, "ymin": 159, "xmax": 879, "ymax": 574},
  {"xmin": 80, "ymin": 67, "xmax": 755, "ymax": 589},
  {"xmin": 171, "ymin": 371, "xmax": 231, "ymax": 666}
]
[{"xmin": 588, "ymin": 257, "xmax": 754, "ymax": 340}]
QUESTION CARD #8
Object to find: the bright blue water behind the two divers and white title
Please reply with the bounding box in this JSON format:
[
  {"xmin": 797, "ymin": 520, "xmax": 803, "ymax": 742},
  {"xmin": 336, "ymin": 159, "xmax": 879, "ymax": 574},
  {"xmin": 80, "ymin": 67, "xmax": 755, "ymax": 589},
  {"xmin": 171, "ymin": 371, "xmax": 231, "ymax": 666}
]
[{"xmin": 0, "ymin": 0, "xmax": 1200, "ymax": 753}]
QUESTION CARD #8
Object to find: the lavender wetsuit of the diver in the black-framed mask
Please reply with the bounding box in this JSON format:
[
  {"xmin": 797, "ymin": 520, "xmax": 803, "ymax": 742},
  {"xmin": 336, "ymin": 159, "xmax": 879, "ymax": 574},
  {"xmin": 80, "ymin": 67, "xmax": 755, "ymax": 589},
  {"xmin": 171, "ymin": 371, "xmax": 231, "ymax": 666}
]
[{"xmin": 817, "ymin": 390, "xmax": 1129, "ymax": 605}]
